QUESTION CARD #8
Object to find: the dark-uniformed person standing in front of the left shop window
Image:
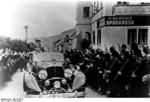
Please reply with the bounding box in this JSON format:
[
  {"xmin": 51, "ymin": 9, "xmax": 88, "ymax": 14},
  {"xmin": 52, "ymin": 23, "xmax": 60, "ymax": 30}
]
[{"xmin": 127, "ymin": 43, "xmax": 143, "ymax": 97}]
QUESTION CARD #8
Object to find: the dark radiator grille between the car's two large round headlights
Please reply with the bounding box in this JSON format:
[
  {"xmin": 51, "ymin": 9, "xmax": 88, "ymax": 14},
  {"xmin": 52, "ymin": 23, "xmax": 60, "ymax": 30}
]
[{"xmin": 46, "ymin": 66, "xmax": 64, "ymax": 79}]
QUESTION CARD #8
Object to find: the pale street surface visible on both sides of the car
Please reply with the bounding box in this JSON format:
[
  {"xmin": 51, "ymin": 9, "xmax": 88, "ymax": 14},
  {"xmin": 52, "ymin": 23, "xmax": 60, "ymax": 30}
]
[{"xmin": 0, "ymin": 72, "xmax": 105, "ymax": 98}]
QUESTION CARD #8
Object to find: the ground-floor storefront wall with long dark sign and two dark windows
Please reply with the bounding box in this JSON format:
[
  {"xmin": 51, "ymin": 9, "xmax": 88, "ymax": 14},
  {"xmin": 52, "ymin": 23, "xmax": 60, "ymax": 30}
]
[{"xmin": 97, "ymin": 16, "xmax": 150, "ymax": 48}]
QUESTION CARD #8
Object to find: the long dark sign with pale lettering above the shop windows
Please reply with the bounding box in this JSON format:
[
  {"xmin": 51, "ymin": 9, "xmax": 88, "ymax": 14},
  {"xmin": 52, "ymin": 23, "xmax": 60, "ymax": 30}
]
[{"xmin": 100, "ymin": 16, "xmax": 150, "ymax": 27}]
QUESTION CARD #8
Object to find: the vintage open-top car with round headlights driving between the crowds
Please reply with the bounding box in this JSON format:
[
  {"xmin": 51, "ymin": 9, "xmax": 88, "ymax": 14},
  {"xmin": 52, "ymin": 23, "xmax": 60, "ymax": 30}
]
[{"xmin": 23, "ymin": 53, "xmax": 85, "ymax": 98}]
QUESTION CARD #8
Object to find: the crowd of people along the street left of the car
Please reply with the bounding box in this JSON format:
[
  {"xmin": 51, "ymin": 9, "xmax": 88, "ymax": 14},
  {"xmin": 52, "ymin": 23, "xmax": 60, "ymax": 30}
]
[{"xmin": 0, "ymin": 48, "xmax": 30, "ymax": 88}]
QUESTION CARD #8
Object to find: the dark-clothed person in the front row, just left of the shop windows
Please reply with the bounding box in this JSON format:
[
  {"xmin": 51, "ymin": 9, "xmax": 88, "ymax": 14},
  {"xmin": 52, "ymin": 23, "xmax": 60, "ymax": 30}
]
[{"xmin": 106, "ymin": 47, "xmax": 127, "ymax": 97}]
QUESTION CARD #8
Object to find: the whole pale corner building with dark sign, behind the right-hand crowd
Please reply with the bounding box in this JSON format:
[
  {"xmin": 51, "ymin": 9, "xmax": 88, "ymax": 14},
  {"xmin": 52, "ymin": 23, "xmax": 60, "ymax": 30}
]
[{"xmin": 76, "ymin": 1, "xmax": 150, "ymax": 49}]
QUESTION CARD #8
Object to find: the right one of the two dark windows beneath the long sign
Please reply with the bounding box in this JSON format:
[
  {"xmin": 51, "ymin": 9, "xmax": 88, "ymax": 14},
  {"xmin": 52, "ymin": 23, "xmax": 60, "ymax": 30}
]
[{"xmin": 138, "ymin": 29, "xmax": 148, "ymax": 45}]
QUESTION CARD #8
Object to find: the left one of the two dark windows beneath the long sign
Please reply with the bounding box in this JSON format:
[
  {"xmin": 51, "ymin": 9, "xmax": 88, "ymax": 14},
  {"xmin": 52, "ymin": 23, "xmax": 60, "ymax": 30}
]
[{"xmin": 127, "ymin": 29, "xmax": 137, "ymax": 44}]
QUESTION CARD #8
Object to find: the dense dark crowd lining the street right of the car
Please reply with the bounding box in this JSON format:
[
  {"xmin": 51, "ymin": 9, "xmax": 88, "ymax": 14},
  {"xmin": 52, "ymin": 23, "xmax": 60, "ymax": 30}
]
[{"xmin": 64, "ymin": 43, "xmax": 150, "ymax": 97}]
